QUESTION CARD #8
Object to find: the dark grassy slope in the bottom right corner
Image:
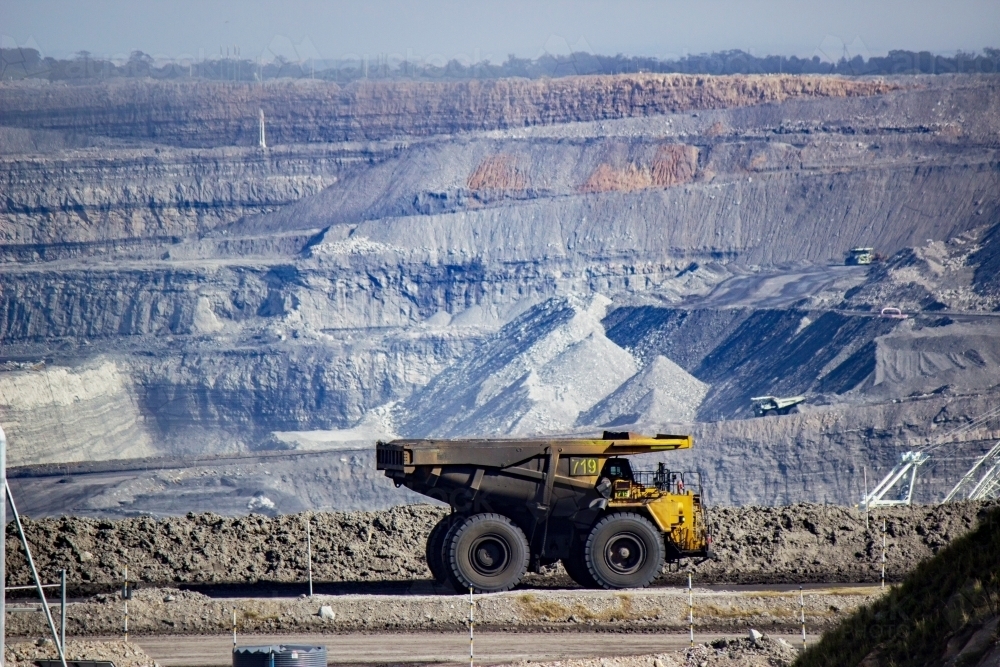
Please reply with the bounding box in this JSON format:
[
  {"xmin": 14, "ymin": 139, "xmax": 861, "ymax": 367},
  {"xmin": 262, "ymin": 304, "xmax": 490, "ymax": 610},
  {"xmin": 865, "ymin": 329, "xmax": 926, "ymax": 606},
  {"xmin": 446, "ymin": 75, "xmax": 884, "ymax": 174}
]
[{"xmin": 795, "ymin": 508, "xmax": 1000, "ymax": 667}]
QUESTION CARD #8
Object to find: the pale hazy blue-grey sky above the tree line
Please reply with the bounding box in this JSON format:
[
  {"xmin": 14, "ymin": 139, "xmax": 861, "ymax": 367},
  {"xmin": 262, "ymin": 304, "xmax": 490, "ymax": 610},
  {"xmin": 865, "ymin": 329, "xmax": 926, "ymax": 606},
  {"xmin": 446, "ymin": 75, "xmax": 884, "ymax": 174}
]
[{"xmin": 0, "ymin": 0, "xmax": 1000, "ymax": 63}]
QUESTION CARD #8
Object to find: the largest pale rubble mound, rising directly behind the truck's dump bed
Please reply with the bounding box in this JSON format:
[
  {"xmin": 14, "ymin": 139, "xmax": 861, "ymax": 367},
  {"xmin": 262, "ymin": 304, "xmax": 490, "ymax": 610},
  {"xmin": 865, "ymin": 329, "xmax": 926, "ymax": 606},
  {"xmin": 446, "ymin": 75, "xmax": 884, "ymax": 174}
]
[{"xmin": 399, "ymin": 297, "xmax": 638, "ymax": 438}]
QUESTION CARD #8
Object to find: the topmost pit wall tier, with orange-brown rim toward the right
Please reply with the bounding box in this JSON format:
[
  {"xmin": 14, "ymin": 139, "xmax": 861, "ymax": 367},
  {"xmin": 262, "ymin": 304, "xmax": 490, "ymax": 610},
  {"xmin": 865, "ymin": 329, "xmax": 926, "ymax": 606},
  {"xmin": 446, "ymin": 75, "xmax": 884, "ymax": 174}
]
[{"xmin": 0, "ymin": 74, "xmax": 901, "ymax": 146}]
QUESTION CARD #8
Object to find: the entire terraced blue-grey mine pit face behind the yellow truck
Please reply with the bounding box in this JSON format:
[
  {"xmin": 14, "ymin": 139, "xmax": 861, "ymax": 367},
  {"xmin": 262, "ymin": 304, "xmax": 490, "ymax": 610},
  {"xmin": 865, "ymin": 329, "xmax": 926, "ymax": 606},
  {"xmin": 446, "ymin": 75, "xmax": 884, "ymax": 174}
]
[{"xmin": 0, "ymin": 75, "xmax": 1000, "ymax": 512}]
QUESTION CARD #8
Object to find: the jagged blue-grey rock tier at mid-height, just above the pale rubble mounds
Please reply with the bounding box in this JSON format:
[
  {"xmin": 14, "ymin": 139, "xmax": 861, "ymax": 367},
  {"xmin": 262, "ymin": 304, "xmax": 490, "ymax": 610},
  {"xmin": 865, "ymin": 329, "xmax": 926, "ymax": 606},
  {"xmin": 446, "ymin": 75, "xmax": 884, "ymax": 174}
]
[{"xmin": 0, "ymin": 252, "xmax": 712, "ymax": 344}]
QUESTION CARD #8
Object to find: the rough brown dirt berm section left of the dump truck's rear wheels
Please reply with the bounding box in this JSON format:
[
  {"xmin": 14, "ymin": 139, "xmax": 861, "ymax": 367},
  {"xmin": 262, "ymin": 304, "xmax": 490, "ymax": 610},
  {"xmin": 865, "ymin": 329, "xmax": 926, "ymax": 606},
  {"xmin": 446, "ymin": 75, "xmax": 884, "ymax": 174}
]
[{"xmin": 7, "ymin": 505, "xmax": 445, "ymax": 591}]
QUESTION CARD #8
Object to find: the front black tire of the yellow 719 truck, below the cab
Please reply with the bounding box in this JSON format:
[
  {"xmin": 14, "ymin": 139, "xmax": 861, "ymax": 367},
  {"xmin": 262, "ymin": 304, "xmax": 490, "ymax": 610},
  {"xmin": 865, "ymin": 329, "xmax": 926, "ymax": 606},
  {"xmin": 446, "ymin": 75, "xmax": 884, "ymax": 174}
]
[{"xmin": 584, "ymin": 512, "xmax": 663, "ymax": 589}]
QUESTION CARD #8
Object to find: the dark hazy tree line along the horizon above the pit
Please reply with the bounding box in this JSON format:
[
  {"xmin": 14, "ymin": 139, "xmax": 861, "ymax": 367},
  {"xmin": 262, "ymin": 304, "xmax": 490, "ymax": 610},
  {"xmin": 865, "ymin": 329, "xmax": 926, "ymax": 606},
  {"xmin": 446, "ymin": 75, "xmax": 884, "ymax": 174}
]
[{"xmin": 0, "ymin": 48, "xmax": 1000, "ymax": 83}]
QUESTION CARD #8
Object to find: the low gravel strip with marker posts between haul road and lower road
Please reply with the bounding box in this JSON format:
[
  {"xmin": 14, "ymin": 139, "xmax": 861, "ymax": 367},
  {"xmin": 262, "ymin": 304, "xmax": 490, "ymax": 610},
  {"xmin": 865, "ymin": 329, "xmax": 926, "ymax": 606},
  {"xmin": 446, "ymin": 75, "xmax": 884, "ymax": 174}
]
[{"xmin": 7, "ymin": 586, "xmax": 882, "ymax": 637}]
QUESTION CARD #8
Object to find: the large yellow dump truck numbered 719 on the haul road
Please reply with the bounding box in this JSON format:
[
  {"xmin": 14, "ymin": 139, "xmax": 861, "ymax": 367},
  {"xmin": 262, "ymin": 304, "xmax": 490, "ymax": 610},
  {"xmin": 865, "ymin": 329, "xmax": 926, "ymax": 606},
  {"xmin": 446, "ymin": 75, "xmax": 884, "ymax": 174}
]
[{"xmin": 376, "ymin": 431, "xmax": 714, "ymax": 592}]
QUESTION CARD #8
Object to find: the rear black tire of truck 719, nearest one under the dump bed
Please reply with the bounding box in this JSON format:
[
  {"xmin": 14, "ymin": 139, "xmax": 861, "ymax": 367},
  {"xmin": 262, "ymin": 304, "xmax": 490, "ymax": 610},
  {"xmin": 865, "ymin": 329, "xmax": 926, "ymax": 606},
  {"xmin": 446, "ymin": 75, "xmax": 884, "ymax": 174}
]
[{"xmin": 448, "ymin": 514, "xmax": 531, "ymax": 593}]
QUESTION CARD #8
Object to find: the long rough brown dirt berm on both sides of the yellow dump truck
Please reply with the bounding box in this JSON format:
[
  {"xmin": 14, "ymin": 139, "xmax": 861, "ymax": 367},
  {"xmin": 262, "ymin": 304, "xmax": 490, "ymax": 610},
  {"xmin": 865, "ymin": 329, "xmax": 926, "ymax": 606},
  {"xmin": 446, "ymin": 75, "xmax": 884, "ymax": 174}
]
[{"xmin": 7, "ymin": 503, "xmax": 995, "ymax": 593}]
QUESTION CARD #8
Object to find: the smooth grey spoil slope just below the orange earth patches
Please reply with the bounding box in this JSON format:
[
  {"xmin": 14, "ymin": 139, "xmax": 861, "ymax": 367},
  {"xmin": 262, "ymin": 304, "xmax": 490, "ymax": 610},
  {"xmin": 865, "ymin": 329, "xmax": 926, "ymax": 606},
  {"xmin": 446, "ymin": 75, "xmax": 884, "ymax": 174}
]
[{"xmin": 288, "ymin": 157, "xmax": 1000, "ymax": 267}]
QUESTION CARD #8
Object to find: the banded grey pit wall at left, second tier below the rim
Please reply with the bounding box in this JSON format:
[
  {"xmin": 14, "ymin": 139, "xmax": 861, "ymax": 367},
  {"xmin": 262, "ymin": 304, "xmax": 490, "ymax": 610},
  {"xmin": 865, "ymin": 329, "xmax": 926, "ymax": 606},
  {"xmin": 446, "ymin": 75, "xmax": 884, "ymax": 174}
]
[{"xmin": 0, "ymin": 145, "xmax": 395, "ymax": 247}]
